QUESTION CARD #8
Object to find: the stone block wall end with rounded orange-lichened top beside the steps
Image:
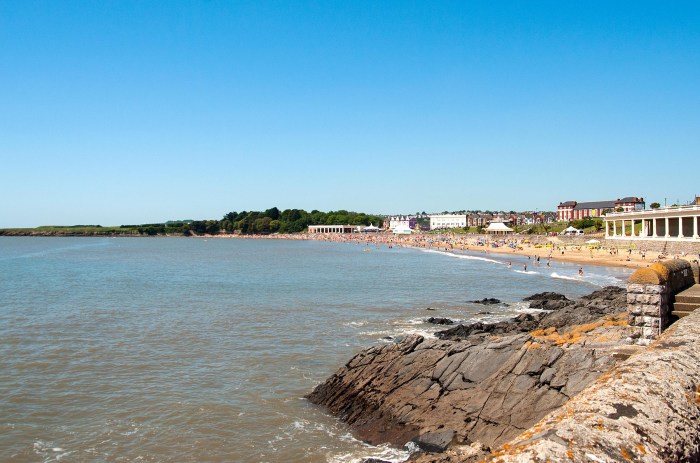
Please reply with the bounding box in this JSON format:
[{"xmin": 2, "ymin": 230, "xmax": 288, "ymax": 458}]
[{"xmin": 627, "ymin": 259, "xmax": 696, "ymax": 345}]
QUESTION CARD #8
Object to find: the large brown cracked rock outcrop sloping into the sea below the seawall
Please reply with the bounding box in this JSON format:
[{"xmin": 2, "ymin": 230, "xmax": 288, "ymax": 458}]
[{"xmin": 308, "ymin": 288, "xmax": 628, "ymax": 461}]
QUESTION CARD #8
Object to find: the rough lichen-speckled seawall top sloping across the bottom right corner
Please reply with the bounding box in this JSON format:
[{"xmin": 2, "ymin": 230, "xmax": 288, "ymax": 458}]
[{"xmin": 486, "ymin": 311, "xmax": 700, "ymax": 463}]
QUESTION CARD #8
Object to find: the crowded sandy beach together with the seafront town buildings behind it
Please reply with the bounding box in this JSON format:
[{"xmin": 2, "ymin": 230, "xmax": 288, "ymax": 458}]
[{"xmin": 308, "ymin": 197, "xmax": 700, "ymax": 267}]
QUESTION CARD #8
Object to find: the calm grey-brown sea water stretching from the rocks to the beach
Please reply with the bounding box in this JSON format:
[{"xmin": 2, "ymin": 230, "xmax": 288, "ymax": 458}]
[{"xmin": 0, "ymin": 237, "xmax": 629, "ymax": 462}]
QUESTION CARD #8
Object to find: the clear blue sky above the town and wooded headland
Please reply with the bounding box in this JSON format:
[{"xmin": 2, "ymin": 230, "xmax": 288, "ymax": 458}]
[{"xmin": 0, "ymin": 0, "xmax": 700, "ymax": 227}]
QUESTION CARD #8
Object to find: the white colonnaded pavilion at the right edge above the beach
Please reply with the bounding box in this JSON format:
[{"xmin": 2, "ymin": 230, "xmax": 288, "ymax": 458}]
[{"xmin": 605, "ymin": 204, "xmax": 700, "ymax": 242}]
